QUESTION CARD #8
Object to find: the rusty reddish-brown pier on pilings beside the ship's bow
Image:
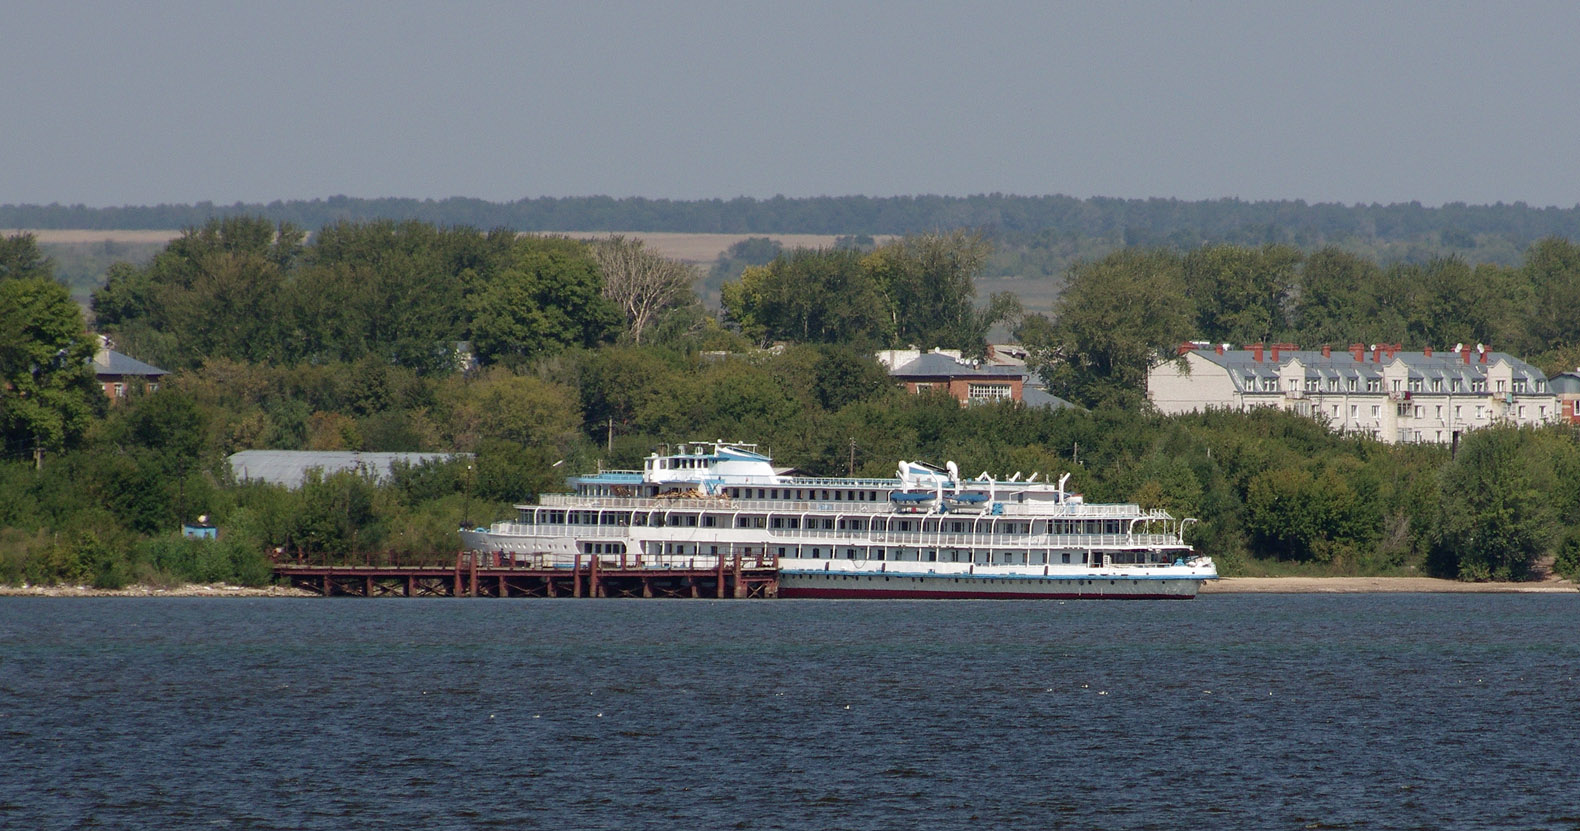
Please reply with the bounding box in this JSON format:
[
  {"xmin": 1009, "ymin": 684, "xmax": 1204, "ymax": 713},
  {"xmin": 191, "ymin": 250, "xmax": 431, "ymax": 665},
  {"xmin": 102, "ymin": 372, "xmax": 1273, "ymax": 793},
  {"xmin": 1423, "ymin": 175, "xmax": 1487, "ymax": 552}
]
[{"xmin": 275, "ymin": 551, "xmax": 779, "ymax": 599}]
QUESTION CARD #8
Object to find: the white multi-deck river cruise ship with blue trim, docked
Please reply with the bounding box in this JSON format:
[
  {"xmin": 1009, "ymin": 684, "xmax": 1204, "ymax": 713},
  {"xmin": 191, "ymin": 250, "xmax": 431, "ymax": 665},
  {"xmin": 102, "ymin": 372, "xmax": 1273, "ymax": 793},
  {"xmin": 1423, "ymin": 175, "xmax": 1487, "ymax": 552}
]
[{"xmin": 461, "ymin": 441, "xmax": 1218, "ymax": 599}]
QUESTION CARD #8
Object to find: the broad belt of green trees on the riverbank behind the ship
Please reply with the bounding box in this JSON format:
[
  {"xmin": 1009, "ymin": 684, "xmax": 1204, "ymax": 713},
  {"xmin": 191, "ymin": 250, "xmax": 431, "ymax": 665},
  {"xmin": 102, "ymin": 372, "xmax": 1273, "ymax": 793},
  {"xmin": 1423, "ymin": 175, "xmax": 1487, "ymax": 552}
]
[{"xmin": 0, "ymin": 218, "xmax": 1580, "ymax": 586}]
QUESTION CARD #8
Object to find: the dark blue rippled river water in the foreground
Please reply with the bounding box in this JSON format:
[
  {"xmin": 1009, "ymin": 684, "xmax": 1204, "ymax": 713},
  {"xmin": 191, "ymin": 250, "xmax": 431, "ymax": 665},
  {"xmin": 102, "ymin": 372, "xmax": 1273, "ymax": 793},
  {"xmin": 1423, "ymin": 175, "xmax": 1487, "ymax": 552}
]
[{"xmin": 0, "ymin": 596, "xmax": 1580, "ymax": 829}]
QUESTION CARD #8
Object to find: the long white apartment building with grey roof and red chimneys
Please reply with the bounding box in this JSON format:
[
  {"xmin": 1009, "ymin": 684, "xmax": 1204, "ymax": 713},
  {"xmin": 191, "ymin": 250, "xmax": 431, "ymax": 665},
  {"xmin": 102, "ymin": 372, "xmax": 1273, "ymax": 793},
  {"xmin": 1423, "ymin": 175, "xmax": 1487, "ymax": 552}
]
[{"xmin": 1147, "ymin": 343, "xmax": 1561, "ymax": 444}]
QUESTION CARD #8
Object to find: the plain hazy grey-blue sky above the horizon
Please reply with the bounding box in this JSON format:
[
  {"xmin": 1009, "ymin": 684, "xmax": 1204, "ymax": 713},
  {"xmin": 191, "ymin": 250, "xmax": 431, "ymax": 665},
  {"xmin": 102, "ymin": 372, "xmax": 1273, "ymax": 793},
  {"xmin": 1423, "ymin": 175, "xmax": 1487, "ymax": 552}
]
[{"xmin": 0, "ymin": 0, "xmax": 1580, "ymax": 207}]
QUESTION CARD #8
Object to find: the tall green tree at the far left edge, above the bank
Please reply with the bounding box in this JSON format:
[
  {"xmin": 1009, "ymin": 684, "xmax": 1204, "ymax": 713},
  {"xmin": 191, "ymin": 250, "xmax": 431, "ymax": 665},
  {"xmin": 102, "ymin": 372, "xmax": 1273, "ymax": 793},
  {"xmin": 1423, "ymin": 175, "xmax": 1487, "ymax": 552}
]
[{"xmin": 0, "ymin": 276, "xmax": 104, "ymax": 464}]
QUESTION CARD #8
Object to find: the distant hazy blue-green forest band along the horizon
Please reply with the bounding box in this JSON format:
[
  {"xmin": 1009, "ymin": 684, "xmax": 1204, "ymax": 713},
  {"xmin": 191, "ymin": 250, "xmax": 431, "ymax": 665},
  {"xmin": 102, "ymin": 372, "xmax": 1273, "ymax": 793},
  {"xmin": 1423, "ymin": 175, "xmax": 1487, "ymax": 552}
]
[{"xmin": 12, "ymin": 193, "xmax": 1580, "ymax": 250}]
